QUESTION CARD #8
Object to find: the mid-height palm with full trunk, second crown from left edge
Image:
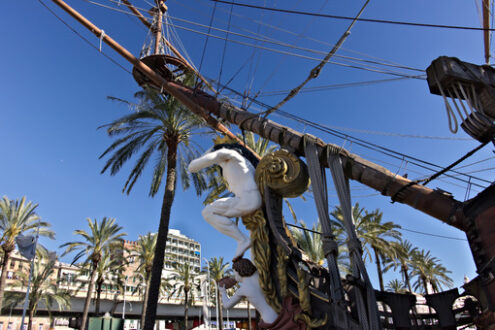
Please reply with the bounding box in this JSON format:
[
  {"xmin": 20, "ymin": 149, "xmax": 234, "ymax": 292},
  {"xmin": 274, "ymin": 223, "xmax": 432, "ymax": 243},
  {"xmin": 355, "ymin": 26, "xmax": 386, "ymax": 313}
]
[{"xmin": 60, "ymin": 217, "xmax": 127, "ymax": 330}]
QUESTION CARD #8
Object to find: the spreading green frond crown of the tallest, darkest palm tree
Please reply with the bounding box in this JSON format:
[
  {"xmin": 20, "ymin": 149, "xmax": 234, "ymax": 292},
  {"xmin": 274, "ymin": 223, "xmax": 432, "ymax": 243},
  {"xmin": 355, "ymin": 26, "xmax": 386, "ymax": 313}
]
[{"xmin": 100, "ymin": 89, "xmax": 209, "ymax": 196}]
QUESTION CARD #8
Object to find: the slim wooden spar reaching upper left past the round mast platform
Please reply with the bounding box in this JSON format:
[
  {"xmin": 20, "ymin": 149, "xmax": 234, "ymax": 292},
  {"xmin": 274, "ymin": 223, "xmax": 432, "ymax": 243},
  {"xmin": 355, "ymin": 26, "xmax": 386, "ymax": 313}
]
[{"xmin": 48, "ymin": 0, "xmax": 256, "ymax": 156}]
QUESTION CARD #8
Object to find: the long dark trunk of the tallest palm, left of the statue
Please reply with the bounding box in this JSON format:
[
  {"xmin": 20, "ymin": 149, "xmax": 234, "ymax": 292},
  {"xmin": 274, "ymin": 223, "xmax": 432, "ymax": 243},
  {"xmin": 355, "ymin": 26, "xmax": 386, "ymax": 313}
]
[{"xmin": 143, "ymin": 141, "xmax": 178, "ymax": 330}]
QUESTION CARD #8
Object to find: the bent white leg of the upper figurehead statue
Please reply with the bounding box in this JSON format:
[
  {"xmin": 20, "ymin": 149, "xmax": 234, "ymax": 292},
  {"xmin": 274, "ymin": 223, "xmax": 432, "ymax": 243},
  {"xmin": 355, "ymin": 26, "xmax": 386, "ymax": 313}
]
[{"xmin": 201, "ymin": 197, "xmax": 251, "ymax": 259}]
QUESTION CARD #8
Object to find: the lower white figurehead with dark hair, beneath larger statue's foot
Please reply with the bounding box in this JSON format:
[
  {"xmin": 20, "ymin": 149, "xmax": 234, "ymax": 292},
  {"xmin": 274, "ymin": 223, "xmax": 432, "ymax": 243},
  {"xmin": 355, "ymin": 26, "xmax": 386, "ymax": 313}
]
[{"xmin": 218, "ymin": 258, "xmax": 278, "ymax": 324}]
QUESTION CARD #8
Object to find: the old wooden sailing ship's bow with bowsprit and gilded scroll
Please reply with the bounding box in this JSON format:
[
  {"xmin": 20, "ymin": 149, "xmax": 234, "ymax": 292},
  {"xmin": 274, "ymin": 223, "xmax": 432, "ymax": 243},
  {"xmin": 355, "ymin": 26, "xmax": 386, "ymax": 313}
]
[{"xmin": 44, "ymin": 0, "xmax": 495, "ymax": 329}]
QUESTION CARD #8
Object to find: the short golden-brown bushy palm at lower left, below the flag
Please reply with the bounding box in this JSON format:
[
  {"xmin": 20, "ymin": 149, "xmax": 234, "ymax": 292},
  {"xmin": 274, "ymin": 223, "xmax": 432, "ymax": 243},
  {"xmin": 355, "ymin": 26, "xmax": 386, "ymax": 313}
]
[{"xmin": 5, "ymin": 250, "xmax": 70, "ymax": 330}]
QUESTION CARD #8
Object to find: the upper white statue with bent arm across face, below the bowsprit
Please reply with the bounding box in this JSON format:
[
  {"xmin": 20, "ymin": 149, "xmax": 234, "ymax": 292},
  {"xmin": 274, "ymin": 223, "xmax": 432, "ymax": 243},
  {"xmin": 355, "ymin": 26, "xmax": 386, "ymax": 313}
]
[{"xmin": 188, "ymin": 144, "xmax": 261, "ymax": 260}]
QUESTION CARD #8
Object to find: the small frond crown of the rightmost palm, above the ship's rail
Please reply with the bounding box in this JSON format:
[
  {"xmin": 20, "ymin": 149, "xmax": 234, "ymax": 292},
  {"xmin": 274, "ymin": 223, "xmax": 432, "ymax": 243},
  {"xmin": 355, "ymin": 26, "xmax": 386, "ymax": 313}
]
[{"xmin": 411, "ymin": 250, "xmax": 453, "ymax": 294}]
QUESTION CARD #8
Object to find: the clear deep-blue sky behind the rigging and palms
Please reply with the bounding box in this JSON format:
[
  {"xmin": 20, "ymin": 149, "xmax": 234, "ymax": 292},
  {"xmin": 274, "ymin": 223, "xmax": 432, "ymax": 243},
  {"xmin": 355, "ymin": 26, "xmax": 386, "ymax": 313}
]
[{"xmin": 0, "ymin": 0, "xmax": 495, "ymax": 292}]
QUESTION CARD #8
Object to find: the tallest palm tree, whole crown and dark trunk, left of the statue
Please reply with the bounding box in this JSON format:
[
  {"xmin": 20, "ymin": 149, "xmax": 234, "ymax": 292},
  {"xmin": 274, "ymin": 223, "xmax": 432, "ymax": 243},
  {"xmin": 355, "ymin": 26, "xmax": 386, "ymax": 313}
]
[{"xmin": 100, "ymin": 90, "xmax": 211, "ymax": 330}]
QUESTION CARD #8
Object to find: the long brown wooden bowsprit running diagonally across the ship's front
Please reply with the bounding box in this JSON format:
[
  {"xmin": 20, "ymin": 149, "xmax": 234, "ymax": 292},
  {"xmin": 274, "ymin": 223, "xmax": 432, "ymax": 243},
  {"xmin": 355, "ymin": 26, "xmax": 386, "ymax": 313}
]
[{"xmin": 48, "ymin": 0, "xmax": 465, "ymax": 231}]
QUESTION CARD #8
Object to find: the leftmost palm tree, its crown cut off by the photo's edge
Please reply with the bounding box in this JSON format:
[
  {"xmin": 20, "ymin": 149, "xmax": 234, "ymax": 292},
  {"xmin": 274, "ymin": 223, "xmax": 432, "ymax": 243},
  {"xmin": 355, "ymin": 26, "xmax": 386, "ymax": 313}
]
[{"xmin": 0, "ymin": 196, "xmax": 55, "ymax": 311}]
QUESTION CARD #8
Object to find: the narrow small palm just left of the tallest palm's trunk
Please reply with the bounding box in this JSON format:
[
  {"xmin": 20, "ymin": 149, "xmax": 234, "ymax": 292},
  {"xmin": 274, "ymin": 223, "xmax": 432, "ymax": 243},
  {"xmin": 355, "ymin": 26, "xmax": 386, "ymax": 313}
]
[{"xmin": 135, "ymin": 233, "xmax": 156, "ymax": 324}]
